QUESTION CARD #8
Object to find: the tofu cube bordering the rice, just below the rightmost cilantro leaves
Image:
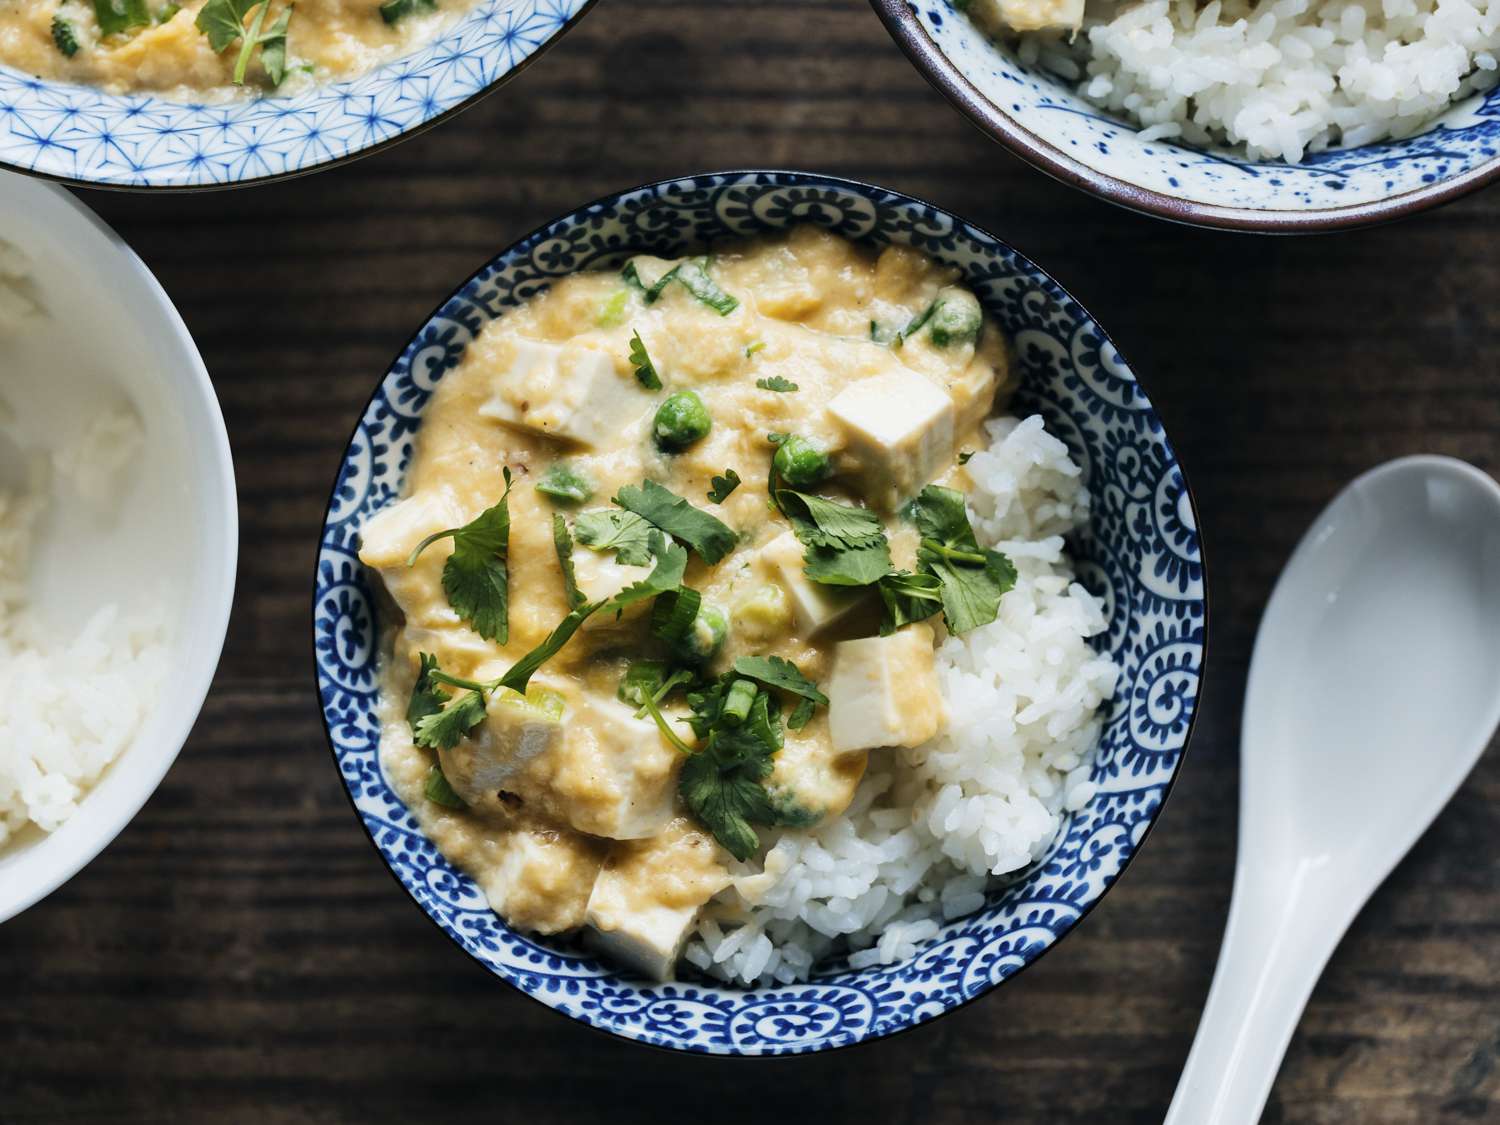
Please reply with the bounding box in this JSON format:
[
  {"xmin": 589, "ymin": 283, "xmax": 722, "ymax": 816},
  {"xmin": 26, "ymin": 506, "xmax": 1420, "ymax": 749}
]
[{"xmin": 828, "ymin": 624, "xmax": 944, "ymax": 753}]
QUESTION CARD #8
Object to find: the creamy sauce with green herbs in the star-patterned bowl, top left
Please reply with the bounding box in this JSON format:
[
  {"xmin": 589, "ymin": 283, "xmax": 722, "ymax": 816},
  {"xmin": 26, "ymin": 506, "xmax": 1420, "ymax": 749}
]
[{"xmin": 0, "ymin": 0, "xmax": 473, "ymax": 102}]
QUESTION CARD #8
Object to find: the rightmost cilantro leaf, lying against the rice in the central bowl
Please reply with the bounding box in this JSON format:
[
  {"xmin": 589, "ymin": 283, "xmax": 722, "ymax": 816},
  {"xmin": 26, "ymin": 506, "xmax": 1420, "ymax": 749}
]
[{"xmin": 912, "ymin": 485, "xmax": 1016, "ymax": 635}]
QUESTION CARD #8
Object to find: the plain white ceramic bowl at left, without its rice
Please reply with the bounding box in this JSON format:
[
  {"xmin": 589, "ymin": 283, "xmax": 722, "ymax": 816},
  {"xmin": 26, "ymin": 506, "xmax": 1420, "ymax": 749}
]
[{"xmin": 0, "ymin": 173, "xmax": 239, "ymax": 921}]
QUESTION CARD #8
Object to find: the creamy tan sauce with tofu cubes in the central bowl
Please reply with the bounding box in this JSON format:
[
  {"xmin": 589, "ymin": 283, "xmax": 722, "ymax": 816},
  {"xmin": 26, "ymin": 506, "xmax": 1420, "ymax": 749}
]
[{"xmin": 362, "ymin": 228, "xmax": 1011, "ymax": 977}]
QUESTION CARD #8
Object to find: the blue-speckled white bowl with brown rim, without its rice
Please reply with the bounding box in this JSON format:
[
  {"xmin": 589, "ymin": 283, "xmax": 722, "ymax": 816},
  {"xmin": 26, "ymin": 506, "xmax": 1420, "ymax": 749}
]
[{"xmin": 870, "ymin": 0, "xmax": 1500, "ymax": 233}]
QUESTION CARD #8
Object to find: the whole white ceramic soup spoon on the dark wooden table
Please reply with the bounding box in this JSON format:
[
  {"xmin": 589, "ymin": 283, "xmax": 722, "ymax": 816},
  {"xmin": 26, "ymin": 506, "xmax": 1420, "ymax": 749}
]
[{"xmin": 1166, "ymin": 458, "xmax": 1500, "ymax": 1125}]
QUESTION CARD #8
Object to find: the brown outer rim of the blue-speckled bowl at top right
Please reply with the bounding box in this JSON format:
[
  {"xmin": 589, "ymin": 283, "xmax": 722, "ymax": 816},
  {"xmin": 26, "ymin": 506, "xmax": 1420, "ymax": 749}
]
[{"xmin": 870, "ymin": 0, "xmax": 1500, "ymax": 234}]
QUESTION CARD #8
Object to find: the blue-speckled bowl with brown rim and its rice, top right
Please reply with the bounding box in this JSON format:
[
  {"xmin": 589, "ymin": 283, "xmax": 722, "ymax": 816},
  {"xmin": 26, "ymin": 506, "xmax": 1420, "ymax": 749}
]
[{"xmin": 872, "ymin": 0, "xmax": 1500, "ymax": 233}]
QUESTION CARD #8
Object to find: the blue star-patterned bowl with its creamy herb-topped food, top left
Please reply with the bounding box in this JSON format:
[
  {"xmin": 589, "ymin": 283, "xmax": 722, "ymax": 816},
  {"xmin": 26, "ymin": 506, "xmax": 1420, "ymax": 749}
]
[{"xmin": 0, "ymin": 0, "xmax": 594, "ymax": 189}]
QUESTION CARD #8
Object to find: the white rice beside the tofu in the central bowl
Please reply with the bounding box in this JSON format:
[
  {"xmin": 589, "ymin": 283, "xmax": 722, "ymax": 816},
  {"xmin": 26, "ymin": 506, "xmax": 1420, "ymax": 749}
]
[{"xmin": 684, "ymin": 417, "xmax": 1118, "ymax": 984}]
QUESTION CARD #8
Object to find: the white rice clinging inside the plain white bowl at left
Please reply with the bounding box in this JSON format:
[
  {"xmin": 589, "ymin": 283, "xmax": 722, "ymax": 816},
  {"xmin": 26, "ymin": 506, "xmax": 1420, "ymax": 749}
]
[{"xmin": 0, "ymin": 249, "xmax": 167, "ymax": 845}]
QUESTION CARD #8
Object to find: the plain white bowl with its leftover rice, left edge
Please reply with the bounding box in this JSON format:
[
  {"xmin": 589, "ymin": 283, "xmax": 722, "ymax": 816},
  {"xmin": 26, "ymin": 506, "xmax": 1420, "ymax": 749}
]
[{"xmin": 0, "ymin": 173, "xmax": 239, "ymax": 921}]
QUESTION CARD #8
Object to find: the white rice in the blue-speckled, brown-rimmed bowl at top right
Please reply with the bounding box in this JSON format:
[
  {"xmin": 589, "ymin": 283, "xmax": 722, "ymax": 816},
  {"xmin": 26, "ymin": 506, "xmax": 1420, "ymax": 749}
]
[{"xmin": 996, "ymin": 0, "xmax": 1500, "ymax": 164}]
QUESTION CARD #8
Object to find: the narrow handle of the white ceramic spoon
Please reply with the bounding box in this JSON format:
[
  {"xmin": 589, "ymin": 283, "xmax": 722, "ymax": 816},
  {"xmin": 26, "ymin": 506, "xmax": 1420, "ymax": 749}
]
[{"xmin": 1164, "ymin": 857, "xmax": 1350, "ymax": 1125}]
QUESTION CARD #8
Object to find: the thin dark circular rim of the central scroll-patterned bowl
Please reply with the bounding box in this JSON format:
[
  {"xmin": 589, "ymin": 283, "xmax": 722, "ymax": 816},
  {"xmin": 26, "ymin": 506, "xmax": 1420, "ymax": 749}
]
[{"xmin": 308, "ymin": 168, "xmax": 1212, "ymax": 1059}]
